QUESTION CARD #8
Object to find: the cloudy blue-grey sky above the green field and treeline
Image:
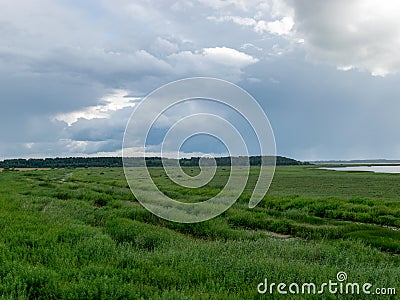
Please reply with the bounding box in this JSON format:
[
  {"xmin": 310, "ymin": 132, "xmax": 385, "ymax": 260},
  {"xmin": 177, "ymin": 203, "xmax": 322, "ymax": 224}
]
[{"xmin": 0, "ymin": 0, "xmax": 400, "ymax": 160}]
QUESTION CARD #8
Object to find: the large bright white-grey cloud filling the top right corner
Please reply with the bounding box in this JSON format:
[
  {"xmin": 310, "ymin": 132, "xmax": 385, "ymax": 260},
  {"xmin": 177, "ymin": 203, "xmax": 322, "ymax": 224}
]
[{"xmin": 286, "ymin": 0, "xmax": 400, "ymax": 76}]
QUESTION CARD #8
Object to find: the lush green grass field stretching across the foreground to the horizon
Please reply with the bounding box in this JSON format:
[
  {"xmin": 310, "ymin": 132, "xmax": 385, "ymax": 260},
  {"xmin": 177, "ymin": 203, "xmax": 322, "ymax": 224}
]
[{"xmin": 0, "ymin": 166, "xmax": 400, "ymax": 299}]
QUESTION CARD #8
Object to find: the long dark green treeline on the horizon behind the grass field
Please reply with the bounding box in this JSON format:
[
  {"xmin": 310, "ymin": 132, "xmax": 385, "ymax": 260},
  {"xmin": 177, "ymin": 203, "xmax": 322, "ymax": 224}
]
[{"xmin": 0, "ymin": 156, "xmax": 304, "ymax": 169}]
